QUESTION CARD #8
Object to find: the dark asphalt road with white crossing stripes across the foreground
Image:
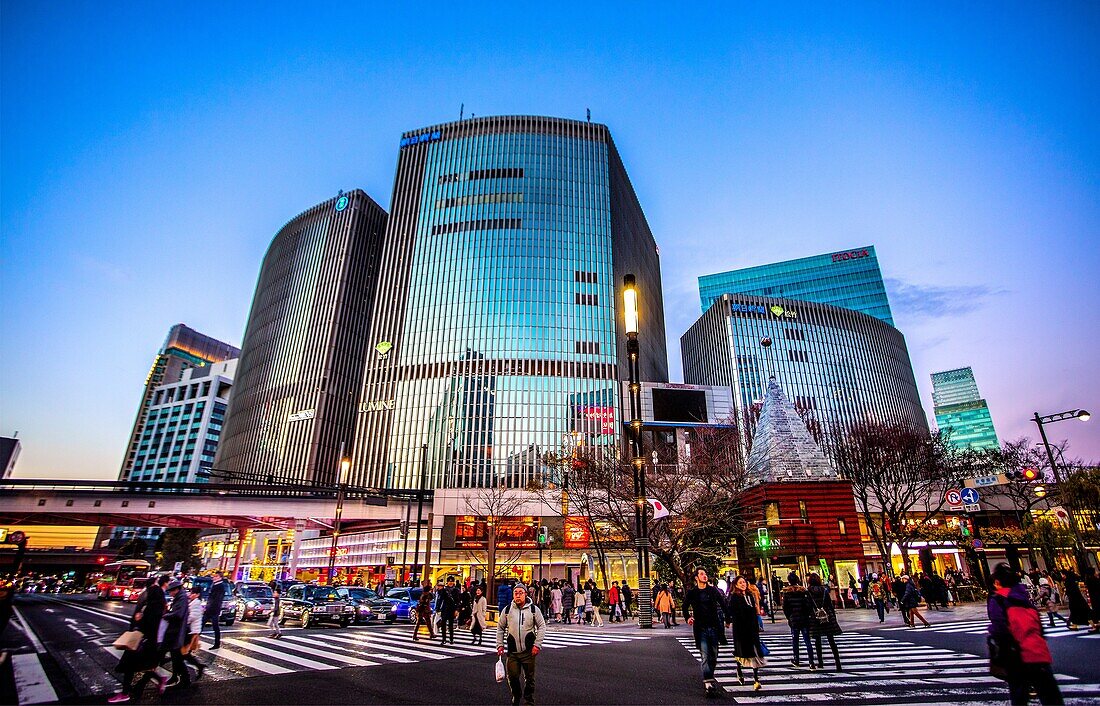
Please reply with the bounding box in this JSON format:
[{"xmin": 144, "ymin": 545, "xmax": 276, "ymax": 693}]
[{"xmin": 0, "ymin": 596, "xmax": 1100, "ymax": 705}]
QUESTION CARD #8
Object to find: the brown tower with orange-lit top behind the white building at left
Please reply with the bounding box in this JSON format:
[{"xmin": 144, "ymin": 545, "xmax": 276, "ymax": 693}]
[{"xmin": 119, "ymin": 323, "xmax": 241, "ymax": 481}]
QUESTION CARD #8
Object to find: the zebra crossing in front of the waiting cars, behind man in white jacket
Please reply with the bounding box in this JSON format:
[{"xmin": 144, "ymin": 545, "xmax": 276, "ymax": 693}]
[{"xmin": 103, "ymin": 626, "xmax": 652, "ymax": 680}]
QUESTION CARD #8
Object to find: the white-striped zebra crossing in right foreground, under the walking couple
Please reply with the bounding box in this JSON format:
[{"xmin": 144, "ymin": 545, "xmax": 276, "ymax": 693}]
[{"xmin": 677, "ymin": 633, "xmax": 1100, "ymax": 706}]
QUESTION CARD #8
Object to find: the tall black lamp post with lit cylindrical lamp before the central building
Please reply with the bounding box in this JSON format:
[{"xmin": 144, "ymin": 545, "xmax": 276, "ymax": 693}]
[{"xmin": 623, "ymin": 275, "xmax": 653, "ymax": 628}]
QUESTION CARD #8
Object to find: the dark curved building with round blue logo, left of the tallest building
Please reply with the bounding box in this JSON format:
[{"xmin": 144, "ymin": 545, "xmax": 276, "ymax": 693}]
[{"xmin": 215, "ymin": 189, "xmax": 386, "ymax": 483}]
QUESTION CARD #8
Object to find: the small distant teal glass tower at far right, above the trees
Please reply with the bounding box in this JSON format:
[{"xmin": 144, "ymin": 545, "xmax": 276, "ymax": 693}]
[{"xmin": 932, "ymin": 366, "xmax": 1001, "ymax": 450}]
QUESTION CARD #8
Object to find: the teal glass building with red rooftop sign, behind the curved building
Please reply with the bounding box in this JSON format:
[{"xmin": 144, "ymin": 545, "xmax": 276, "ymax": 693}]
[{"xmin": 699, "ymin": 245, "xmax": 893, "ymax": 326}]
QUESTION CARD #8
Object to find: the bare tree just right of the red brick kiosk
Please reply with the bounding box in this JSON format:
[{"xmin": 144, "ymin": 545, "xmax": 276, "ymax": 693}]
[{"xmin": 833, "ymin": 422, "xmax": 978, "ymax": 573}]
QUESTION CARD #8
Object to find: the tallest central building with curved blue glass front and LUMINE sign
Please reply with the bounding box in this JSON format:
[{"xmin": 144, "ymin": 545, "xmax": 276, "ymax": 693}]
[{"xmin": 352, "ymin": 117, "xmax": 668, "ymax": 488}]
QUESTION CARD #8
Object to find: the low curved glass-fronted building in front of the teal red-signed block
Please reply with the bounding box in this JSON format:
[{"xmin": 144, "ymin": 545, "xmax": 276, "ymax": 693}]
[{"xmin": 680, "ymin": 295, "xmax": 928, "ymax": 446}]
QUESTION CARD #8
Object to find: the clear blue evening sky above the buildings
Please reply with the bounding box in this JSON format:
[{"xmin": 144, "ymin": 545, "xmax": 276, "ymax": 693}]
[{"xmin": 0, "ymin": 0, "xmax": 1100, "ymax": 477}]
